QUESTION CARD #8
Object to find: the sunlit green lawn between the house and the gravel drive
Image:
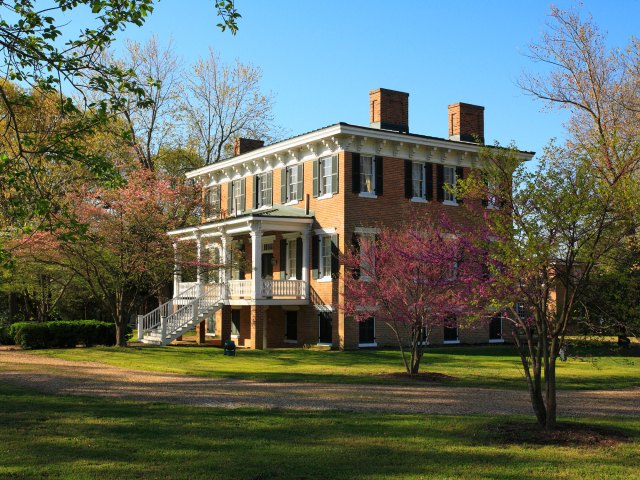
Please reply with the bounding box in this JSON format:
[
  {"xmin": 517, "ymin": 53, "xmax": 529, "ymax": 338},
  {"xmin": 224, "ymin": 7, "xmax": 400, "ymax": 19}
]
[{"xmin": 26, "ymin": 346, "xmax": 640, "ymax": 389}]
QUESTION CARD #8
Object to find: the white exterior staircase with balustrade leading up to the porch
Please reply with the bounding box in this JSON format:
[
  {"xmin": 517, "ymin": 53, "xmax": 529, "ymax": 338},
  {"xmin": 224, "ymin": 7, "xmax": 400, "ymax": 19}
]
[{"xmin": 138, "ymin": 284, "xmax": 224, "ymax": 345}]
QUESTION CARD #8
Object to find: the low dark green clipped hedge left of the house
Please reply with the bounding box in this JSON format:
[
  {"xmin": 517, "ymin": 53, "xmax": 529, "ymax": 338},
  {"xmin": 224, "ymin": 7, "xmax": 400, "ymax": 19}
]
[{"xmin": 9, "ymin": 320, "xmax": 116, "ymax": 348}]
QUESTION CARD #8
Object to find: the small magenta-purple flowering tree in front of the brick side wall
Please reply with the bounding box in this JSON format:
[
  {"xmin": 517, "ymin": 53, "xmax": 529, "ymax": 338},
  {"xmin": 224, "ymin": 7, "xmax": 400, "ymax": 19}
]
[{"xmin": 341, "ymin": 218, "xmax": 492, "ymax": 375}]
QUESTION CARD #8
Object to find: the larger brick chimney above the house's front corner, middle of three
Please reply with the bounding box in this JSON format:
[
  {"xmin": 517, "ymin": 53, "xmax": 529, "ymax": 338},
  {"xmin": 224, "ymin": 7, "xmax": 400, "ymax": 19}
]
[{"xmin": 369, "ymin": 88, "xmax": 409, "ymax": 133}]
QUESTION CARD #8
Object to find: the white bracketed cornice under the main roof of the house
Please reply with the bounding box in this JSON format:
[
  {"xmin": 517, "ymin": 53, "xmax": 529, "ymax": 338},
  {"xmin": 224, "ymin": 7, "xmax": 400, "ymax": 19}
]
[{"xmin": 187, "ymin": 123, "xmax": 533, "ymax": 186}]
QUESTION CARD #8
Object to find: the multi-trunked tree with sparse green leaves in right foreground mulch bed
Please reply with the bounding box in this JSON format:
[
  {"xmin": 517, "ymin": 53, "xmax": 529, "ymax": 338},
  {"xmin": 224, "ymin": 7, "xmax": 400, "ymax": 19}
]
[{"xmin": 461, "ymin": 144, "xmax": 637, "ymax": 429}]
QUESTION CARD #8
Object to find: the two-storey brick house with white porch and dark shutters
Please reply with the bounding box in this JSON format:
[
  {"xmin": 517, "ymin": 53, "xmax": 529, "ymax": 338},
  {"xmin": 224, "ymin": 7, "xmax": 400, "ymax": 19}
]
[{"xmin": 138, "ymin": 89, "xmax": 533, "ymax": 349}]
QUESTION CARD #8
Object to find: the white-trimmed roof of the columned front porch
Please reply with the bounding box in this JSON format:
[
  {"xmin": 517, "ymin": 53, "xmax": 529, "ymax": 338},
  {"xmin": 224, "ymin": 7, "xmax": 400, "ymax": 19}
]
[{"xmin": 167, "ymin": 205, "xmax": 314, "ymax": 241}]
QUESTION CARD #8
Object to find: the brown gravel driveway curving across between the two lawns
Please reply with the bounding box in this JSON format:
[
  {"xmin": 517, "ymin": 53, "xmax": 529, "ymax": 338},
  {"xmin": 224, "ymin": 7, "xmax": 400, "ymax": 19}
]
[{"xmin": 0, "ymin": 351, "xmax": 640, "ymax": 416}]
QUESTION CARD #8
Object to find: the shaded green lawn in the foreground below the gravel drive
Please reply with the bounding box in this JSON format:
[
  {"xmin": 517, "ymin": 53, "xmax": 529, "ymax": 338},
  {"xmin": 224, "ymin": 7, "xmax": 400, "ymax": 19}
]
[{"xmin": 0, "ymin": 385, "xmax": 640, "ymax": 480}]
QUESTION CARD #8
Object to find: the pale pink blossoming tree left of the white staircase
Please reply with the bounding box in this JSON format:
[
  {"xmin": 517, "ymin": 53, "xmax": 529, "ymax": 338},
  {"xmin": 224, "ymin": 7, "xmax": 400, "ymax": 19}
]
[{"xmin": 18, "ymin": 169, "xmax": 199, "ymax": 346}]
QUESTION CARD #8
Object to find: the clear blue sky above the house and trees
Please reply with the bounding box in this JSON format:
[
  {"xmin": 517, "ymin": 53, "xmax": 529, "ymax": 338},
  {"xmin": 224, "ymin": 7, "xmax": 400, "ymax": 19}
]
[{"xmin": 101, "ymin": 0, "xmax": 640, "ymax": 159}]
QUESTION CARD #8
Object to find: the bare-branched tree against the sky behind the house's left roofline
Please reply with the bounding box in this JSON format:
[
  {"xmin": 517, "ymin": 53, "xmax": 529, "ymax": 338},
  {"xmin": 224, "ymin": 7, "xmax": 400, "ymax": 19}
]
[{"xmin": 181, "ymin": 50, "xmax": 279, "ymax": 164}]
